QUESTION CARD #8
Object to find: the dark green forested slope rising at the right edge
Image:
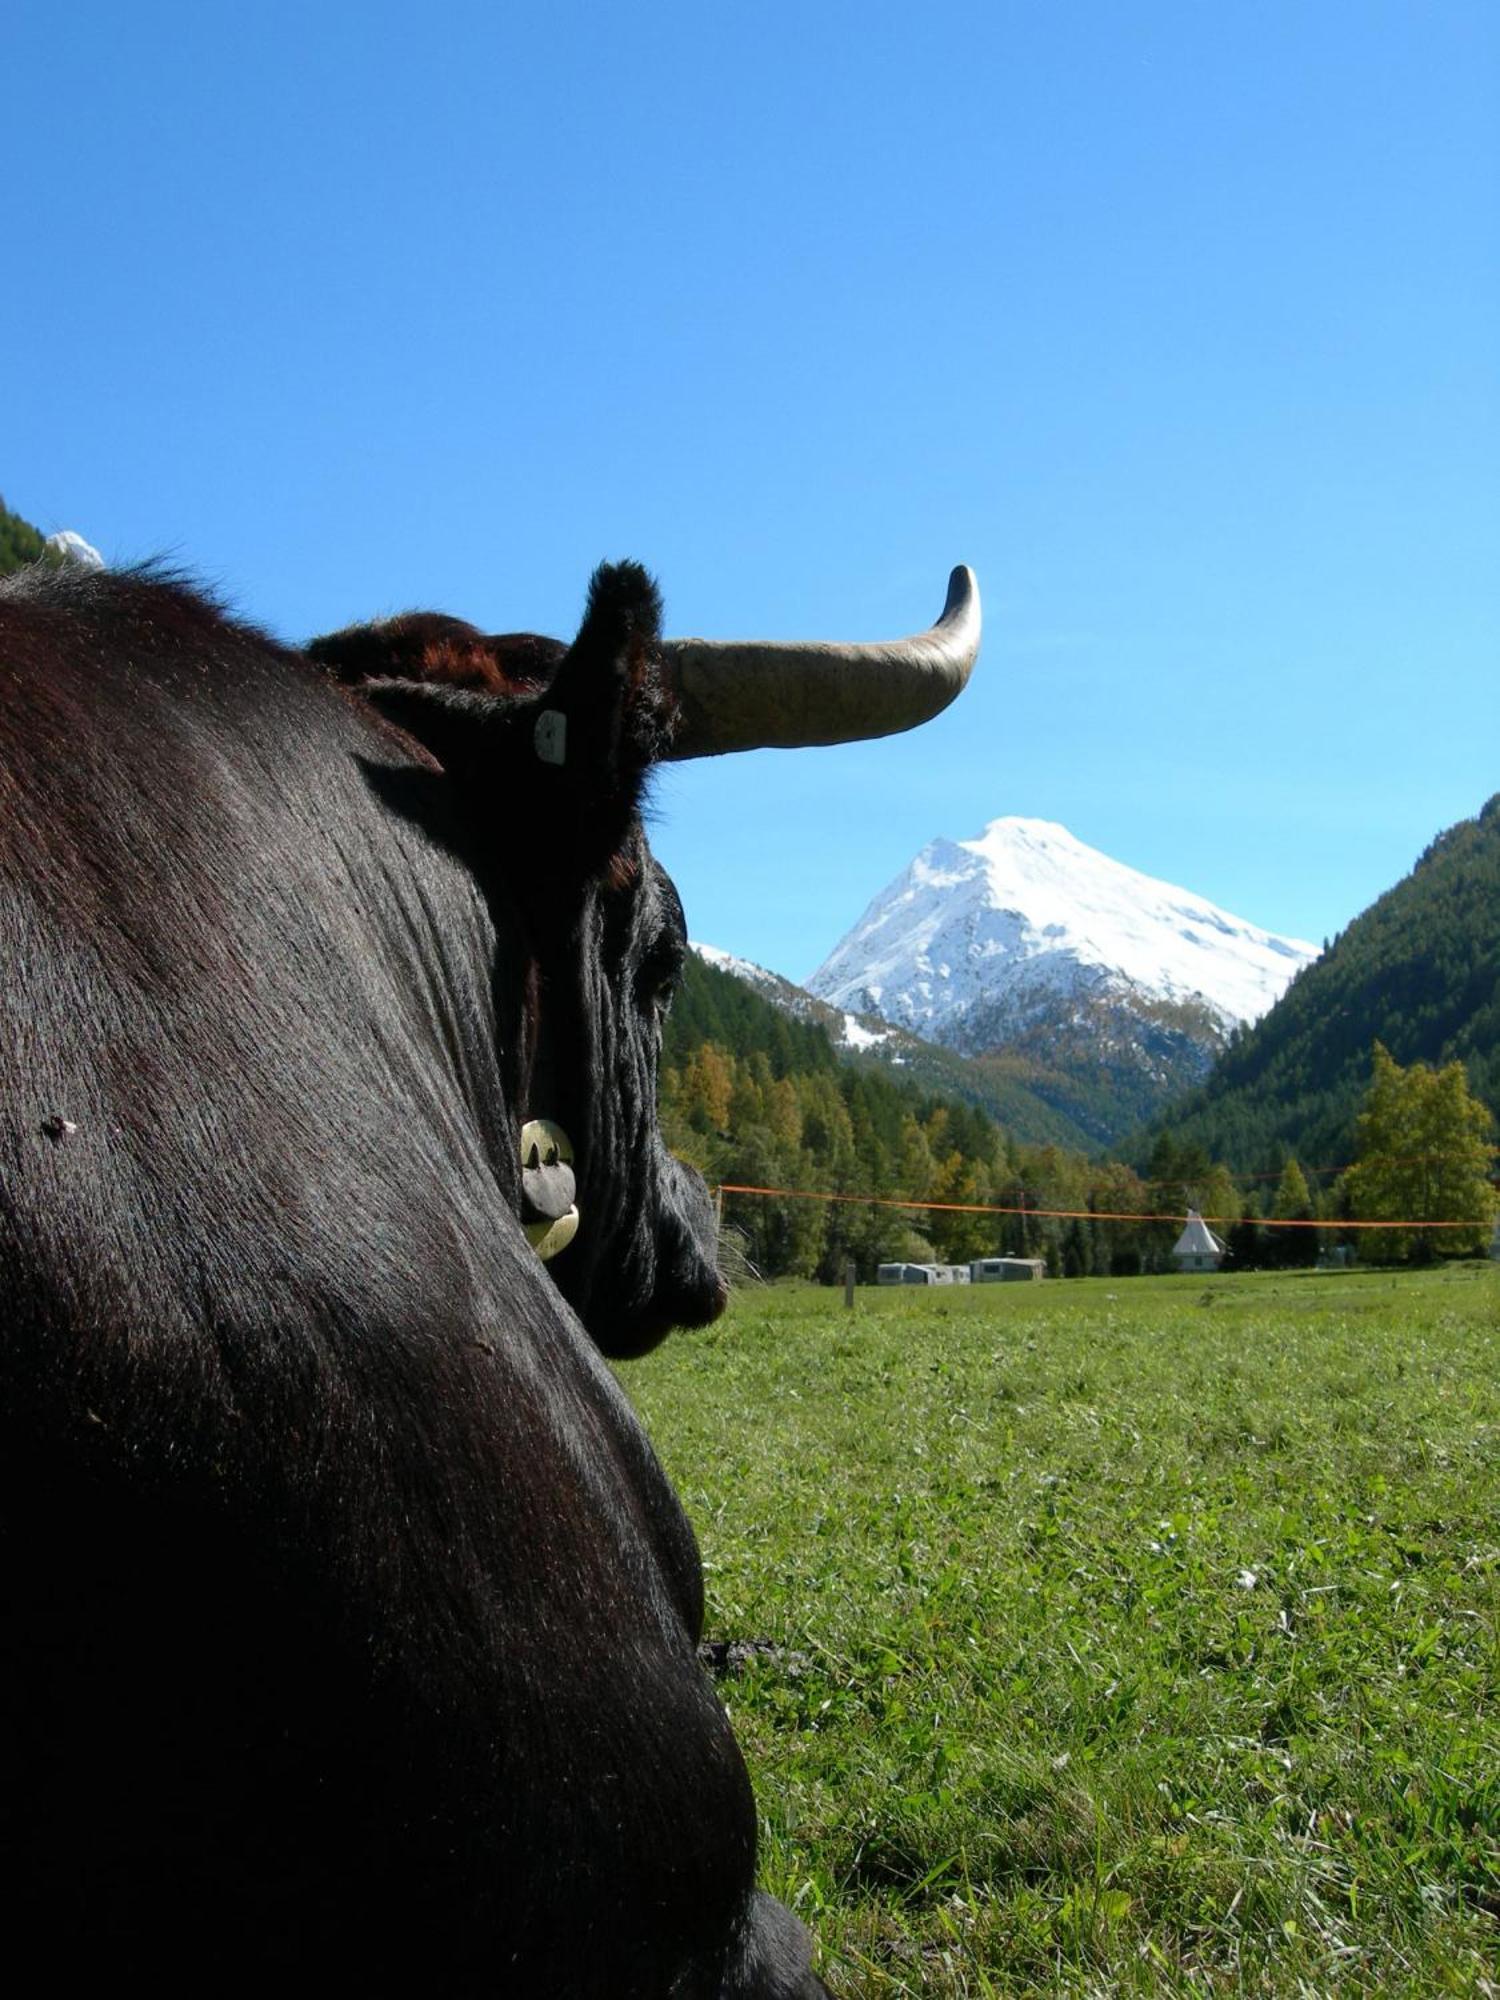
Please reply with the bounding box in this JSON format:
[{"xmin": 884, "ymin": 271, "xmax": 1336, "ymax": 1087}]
[{"xmin": 1132, "ymin": 794, "xmax": 1500, "ymax": 1172}]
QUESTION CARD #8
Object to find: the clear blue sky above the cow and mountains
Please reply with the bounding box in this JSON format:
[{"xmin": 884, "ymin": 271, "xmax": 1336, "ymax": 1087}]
[{"xmin": 0, "ymin": 0, "xmax": 1500, "ymax": 978}]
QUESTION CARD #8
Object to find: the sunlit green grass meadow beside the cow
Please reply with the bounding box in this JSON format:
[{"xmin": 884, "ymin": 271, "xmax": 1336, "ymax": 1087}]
[{"xmin": 622, "ymin": 1264, "xmax": 1500, "ymax": 2000}]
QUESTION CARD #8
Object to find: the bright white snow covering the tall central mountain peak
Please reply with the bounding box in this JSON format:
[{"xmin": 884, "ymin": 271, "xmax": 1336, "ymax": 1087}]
[{"xmin": 808, "ymin": 818, "xmax": 1318, "ymax": 1048}]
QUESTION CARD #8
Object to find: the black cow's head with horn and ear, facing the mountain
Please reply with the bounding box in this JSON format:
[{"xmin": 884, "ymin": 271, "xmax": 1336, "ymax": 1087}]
[{"xmin": 310, "ymin": 564, "xmax": 980, "ymax": 1356}]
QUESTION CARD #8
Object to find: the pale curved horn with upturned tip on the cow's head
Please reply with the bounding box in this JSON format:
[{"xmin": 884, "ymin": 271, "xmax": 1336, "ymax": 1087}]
[{"xmin": 662, "ymin": 564, "xmax": 980, "ymax": 760}]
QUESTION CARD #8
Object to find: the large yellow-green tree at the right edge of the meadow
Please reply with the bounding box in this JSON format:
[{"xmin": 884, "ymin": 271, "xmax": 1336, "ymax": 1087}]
[{"xmin": 1344, "ymin": 1042, "xmax": 1496, "ymax": 1262}]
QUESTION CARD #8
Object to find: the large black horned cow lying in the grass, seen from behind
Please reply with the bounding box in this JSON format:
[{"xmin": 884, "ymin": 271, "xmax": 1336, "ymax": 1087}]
[{"xmin": 0, "ymin": 566, "xmax": 978, "ymax": 2000}]
